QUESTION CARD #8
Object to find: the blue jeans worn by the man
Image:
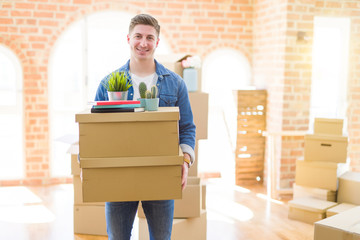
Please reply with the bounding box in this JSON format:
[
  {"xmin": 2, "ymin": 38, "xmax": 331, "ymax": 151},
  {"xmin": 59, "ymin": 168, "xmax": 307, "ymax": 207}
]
[{"xmin": 105, "ymin": 200, "xmax": 174, "ymax": 240}]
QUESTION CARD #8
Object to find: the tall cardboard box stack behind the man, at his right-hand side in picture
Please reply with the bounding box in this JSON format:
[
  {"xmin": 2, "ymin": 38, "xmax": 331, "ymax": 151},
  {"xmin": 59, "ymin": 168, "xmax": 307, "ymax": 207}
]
[{"xmin": 138, "ymin": 55, "xmax": 209, "ymax": 240}]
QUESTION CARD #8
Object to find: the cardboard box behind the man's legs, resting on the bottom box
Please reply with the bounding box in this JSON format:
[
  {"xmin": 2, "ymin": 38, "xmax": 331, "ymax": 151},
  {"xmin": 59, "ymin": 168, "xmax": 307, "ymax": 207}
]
[{"xmin": 138, "ymin": 177, "xmax": 202, "ymax": 218}]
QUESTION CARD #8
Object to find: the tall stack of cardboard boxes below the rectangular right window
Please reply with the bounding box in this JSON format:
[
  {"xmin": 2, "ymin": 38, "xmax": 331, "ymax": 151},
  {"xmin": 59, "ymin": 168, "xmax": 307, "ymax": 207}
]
[{"xmin": 289, "ymin": 118, "xmax": 348, "ymax": 223}]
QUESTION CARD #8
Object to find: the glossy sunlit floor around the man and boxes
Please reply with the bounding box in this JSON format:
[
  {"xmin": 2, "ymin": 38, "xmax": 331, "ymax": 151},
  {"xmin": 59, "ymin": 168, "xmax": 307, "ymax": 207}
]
[{"xmin": 0, "ymin": 179, "xmax": 313, "ymax": 240}]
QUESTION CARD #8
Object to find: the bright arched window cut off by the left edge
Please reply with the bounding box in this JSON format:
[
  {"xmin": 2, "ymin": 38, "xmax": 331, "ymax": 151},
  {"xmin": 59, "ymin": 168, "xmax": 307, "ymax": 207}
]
[{"xmin": 0, "ymin": 45, "xmax": 24, "ymax": 179}]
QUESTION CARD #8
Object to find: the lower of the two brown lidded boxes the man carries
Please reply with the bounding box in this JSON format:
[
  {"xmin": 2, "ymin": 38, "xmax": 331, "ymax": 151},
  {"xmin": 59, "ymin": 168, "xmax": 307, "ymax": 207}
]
[{"xmin": 80, "ymin": 152, "xmax": 184, "ymax": 202}]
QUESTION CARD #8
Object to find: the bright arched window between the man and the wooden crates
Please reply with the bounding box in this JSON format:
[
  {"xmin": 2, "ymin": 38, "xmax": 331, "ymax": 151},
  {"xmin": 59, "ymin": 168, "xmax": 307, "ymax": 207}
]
[{"xmin": 199, "ymin": 48, "xmax": 251, "ymax": 180}]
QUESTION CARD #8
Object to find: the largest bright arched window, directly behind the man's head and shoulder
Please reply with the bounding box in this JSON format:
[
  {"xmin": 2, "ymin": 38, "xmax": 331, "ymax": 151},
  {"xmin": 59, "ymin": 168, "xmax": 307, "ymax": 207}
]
[{"xmin": 49, "ymin": 11, "xmax": 169, "ymax": 176}]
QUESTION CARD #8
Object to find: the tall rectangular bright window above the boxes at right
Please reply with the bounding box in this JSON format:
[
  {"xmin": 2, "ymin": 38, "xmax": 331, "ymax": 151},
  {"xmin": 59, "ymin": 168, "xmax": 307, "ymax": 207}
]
[{"xmin": 309, "ymin": 17, "xmax": 350, "ymax": 131}]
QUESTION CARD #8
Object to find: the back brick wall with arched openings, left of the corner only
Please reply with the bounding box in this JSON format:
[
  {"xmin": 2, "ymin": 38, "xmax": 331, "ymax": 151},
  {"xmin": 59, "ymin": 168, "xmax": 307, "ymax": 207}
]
[{"xmin": 0, "ymin": 0, "xmax": 253, "ymax": 185}]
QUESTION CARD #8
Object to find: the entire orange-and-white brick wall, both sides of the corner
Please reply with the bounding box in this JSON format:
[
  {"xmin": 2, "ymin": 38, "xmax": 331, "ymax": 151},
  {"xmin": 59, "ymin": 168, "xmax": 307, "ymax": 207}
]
[{"xmin": 0, "ymin": 0, "xmax": 360, "ymax": 188}]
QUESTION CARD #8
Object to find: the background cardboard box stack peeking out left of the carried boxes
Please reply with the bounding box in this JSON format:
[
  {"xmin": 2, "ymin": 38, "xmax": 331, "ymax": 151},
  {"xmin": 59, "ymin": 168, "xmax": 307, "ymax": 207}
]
[{"xmin": 68, "ymin": 144, "xmax": 107, "ymax": 236}]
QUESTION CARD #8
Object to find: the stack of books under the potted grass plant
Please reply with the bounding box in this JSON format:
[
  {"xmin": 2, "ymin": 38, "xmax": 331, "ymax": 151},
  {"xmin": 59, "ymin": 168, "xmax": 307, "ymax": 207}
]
[{"xmin": 89, "ymin": 100, "xmax": 145, "ymax": 113}]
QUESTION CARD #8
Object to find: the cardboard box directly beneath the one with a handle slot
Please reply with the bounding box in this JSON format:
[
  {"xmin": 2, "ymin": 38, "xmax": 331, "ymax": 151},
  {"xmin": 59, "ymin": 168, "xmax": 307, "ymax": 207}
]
[{"xmin": 295, "ymin": 160, "xmax": 348, "ymax": 191}]
